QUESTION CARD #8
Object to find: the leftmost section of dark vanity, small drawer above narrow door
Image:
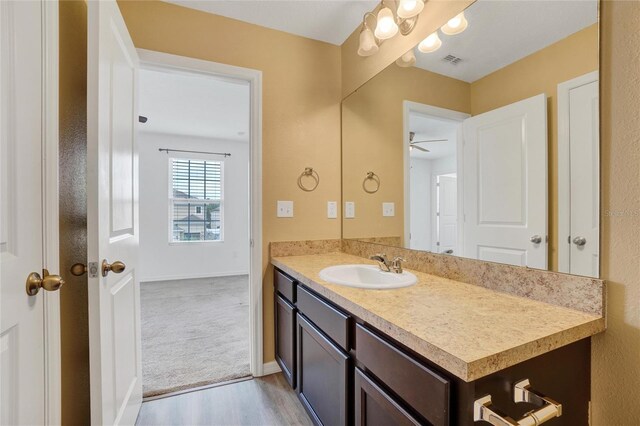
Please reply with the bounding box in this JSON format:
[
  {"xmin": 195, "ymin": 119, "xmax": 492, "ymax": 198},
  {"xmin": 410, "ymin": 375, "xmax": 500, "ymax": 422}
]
[{"xmin": 274, "ymin": 271, "xmax": 297, "ymax": 389}]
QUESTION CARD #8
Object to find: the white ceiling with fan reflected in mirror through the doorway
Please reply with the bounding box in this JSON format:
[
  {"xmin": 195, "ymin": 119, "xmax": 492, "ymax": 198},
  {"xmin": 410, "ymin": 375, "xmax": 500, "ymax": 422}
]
[{"xmin": 409, "ymin": 112, "xmax": 460, "ymax": 160}]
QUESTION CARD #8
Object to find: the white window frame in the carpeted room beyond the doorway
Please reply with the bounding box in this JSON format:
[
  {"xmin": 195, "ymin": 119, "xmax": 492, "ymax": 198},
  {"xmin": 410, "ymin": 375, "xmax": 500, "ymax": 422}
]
[{"xmin": 167, "ymin": 155, "xmax": 225, "ymax": 245}]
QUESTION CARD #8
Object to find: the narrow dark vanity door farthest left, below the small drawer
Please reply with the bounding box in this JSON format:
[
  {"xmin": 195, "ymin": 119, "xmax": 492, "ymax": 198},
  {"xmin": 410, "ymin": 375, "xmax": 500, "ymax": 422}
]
[{"xmin": 275, "ymin": 294, "xmax": 296, "ymax": 389}]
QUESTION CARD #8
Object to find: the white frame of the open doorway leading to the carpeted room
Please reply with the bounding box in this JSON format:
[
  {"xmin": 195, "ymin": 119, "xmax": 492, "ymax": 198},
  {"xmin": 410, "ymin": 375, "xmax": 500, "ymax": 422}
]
[{"xmin": 137, "ymin": 49, "xmax": 264, "ymax": 376}]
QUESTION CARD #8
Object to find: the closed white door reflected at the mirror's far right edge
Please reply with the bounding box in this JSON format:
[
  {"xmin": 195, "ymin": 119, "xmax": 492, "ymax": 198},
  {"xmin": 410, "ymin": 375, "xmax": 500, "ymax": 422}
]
[{"xmin": 561, "ymin": 81, "xmax": 600, "ymax": 277}]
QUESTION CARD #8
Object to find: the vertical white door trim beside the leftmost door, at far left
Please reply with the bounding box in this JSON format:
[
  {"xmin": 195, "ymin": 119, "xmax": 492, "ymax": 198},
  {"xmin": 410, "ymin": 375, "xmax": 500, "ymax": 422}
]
[{"xmin": 42, "ymin": 0, "xmax": 61, "ymax": 425}]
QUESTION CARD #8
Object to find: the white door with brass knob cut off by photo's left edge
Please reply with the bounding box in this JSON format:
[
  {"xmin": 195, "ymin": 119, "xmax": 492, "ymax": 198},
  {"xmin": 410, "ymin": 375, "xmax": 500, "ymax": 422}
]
[{"xmin": 0, "ymin": 1, "xmax": 61, "ymax": 425}]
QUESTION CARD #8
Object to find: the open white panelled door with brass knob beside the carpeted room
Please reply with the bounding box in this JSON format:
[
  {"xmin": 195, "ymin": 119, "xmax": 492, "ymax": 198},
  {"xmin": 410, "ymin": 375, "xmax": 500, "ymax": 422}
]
[{"xmin": 87, "ymin": 0, "xmax": 142, "ymax": 425}]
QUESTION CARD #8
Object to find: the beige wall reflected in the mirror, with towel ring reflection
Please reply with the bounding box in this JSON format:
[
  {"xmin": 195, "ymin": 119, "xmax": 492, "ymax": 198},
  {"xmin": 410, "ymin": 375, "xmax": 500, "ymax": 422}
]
[{"xmin": 342, "ymin": 24, "xmax": 598, "ymax": 270}]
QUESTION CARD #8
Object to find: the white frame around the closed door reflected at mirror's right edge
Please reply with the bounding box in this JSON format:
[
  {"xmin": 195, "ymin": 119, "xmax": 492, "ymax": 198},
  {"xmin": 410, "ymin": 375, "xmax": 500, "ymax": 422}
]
[{"xmin": 558, "ymin": 71, "xmax": 599, "ymax": 273}]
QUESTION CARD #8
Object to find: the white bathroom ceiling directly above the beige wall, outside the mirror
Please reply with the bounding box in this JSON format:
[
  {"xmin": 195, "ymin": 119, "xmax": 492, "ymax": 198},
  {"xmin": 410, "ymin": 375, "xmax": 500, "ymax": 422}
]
[{"xmin": 167, "ymin": 0, "xmax": 379, "ymax": 45}]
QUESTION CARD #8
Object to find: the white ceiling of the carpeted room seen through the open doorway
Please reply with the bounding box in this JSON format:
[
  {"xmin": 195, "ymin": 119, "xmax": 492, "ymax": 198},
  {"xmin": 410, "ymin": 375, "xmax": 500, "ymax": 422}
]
[{"xmin": 138, "ymin": 70, "xmax": 250, "ymax": 141}]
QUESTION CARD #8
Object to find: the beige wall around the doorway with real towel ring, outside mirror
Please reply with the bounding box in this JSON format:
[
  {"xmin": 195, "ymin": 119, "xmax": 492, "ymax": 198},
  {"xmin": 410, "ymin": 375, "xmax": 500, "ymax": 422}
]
[{"xmin": 118, "ymin": 1, "xmax": 341, "ymax": 362}]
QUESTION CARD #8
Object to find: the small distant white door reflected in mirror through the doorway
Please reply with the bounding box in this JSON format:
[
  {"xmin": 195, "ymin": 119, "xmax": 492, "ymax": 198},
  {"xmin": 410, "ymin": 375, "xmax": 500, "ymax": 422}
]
[{"xmin": 436, "ymin": 175, "xmax": 458, "ymax": 255}]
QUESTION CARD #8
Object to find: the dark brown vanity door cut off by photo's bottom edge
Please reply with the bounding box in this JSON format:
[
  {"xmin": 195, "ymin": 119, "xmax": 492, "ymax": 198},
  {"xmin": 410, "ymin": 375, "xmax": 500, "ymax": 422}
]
[{"xmin": 354, "ymin": 368, "xmax": 420, "ymax": 426}]
